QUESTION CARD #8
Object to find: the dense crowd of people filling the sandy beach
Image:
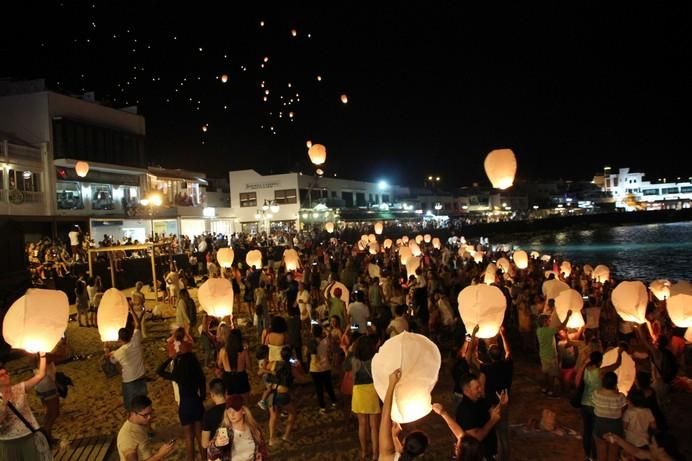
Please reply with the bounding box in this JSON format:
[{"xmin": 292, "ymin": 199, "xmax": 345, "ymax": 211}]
[{"xmin": 0, "ymin": 224, "xmax": 689, "ymax": 461}]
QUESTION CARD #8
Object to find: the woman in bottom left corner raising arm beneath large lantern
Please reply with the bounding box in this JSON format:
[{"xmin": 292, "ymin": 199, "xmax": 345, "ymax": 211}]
[{"xmin": 0, "ymin": 352, "xmax": 50, "ymax": 460}]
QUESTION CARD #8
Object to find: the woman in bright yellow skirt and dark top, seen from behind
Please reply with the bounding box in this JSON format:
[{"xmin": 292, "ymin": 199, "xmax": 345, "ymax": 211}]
[{"xmin": 344, "ymin": 336, "xmax": 381, "ymax": 461}]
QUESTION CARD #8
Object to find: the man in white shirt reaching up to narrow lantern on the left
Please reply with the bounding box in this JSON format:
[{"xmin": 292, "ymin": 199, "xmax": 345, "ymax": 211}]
[{"xmin": 105, "ymin": 308, "xmax": 147, "ymax": 410}]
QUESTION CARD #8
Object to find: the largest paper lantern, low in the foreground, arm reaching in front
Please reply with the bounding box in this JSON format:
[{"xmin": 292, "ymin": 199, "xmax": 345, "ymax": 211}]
[{"xmin": 372, "ymin": 331, "xmax": 442, "ymax": 424}]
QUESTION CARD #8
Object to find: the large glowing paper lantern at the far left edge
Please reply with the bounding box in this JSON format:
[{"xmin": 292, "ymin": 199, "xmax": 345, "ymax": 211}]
[{"xmin": 2, "ymin": 288, "xmax": 70, "ymax": 353}]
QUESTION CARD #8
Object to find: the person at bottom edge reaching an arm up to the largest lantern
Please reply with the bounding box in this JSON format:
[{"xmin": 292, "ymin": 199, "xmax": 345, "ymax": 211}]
[{"xmin": 378, "ymin": 369, "xmax": 428, "ymax": 461}]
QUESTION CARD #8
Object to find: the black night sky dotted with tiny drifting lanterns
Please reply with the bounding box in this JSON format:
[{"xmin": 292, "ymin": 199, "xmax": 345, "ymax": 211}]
[{"xmin": 0, "ymin": 0, "xmax": 692, "ymax": 186}]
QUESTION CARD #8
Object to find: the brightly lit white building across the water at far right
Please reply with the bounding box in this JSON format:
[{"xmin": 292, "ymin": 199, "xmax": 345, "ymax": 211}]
[{"xmin": 603, "ymin": 168, "xmax": 692, "ymax": 210}]
